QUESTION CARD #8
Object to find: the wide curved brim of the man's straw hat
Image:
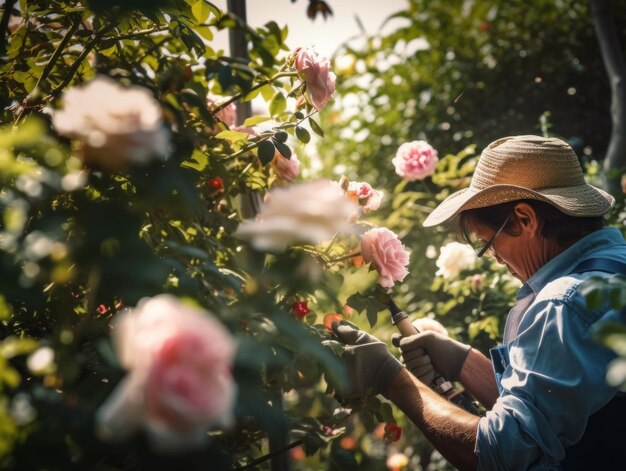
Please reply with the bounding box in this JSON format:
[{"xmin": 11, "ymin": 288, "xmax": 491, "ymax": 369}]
[{"xmin": 424, "ymin": 184, "xmax": 615, "ymax": 227}]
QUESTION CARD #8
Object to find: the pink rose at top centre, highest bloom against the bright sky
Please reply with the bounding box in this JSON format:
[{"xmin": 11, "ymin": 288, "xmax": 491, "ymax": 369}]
[{"xmin": 294, "ymin": 48, "xmax": 336, "ymax": 111}]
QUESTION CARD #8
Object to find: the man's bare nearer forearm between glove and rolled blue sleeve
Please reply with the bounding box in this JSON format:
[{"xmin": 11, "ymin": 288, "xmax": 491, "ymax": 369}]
[{"xmin": 385, "ymin": 369, "xmax": 480, "ymax": 470}]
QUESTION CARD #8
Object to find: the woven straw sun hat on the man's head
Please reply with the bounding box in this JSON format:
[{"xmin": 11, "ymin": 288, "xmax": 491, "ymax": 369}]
[{"xmin": 424, "ymin": 136, "xmax": 615, "ymax": 227}]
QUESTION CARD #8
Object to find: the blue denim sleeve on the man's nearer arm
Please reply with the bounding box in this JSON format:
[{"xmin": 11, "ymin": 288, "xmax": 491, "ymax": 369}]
[{"xmin": 476, "ymin": 291, "xmax": 615, "ymax": 470}]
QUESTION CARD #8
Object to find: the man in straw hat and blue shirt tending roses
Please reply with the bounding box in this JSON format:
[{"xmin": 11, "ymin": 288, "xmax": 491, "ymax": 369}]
[{"xmin": 335, "ymin": 136, "xmax": 626, "ymax": 470}]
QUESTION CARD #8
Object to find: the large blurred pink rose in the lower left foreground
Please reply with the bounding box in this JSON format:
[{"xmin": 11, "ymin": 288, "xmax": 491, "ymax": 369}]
[{"xmin": 97, "ymin": 295, "xmax": 236, "ymax": 450}]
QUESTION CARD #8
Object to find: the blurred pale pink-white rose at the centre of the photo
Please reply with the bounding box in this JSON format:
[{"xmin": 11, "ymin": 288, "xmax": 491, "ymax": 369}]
[{"xmin": 236, "ymin": 180, "xmax": 356, "ymax": 252}]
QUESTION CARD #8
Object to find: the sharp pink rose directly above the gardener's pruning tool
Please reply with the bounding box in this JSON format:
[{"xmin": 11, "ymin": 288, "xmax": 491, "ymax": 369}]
[{"xmin": 361, "ymin": 227, "xmax": 409, "ymax": 288}]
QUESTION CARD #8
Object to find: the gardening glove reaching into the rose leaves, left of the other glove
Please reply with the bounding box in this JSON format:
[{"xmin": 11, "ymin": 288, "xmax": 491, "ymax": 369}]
[{"xmin": 333, "ymin": 321, "xmax": 404, "ymax": 396}]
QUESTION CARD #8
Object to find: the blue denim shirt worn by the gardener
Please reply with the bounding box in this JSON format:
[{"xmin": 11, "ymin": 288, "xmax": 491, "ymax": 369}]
[{"xmin": 476, "ymin": 228, "xmax": 626, "ymax": 471}]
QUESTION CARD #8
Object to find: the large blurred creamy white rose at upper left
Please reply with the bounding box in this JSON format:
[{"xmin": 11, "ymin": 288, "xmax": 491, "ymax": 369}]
[{"xmin": 52, "ymin": 76, "xmax": 168, "ymax": 171}]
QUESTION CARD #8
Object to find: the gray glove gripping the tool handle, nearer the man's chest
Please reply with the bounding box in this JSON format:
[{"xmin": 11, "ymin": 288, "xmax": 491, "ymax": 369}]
[{"xmin": 392, "ymin": 330, "xmax": 472, "ymax": 384}]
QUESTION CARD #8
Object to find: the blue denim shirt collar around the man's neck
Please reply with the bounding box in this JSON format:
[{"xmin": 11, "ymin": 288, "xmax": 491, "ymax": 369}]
[{"xmin": 517, "ymin": 227, "xmax": 624, "ymax": 299}]
